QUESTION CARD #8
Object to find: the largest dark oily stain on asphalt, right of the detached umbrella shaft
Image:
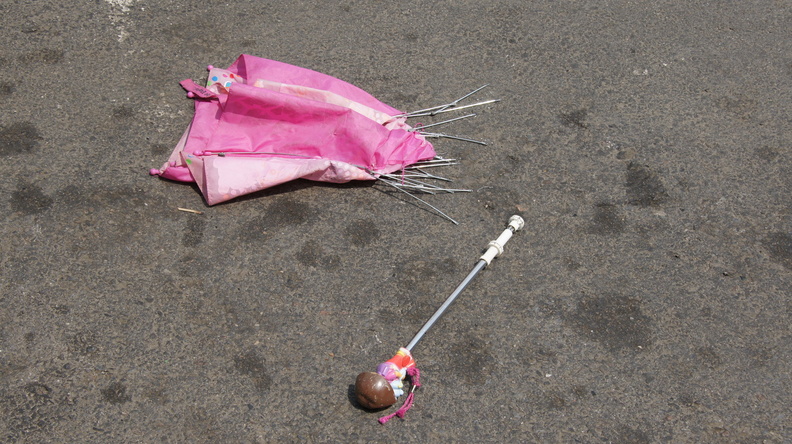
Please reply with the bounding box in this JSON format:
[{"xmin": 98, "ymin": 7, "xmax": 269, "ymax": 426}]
[{"xmin": 568, "ymin": 296, "xmax": 651, "ymax": 352}]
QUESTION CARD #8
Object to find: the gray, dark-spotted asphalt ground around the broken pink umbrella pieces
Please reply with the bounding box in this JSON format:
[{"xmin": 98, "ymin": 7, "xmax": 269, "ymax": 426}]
[{"xmin": 0, "ymin": 0, "xmax": 792, "ymax": 443}]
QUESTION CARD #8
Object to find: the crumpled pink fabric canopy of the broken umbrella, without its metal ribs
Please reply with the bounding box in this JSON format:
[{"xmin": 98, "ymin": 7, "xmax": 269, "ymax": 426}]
[{"xmin": 151, "ymin": 55, "xmax": 435, "ymax": 205}]
